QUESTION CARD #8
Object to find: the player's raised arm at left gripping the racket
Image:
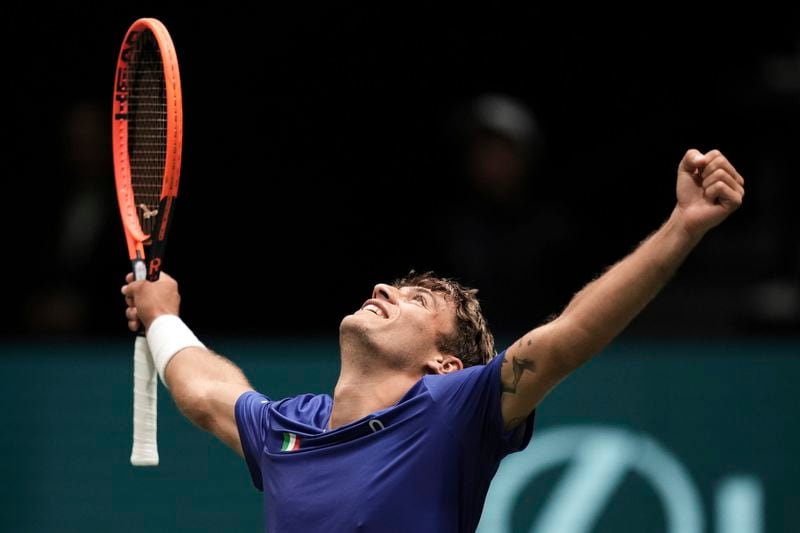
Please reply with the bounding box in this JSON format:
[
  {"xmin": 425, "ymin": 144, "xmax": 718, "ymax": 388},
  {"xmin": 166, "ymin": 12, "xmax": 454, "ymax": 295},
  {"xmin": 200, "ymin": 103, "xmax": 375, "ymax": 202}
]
[{"xmin": 122, "ymin": 273, "xmax": 252, "ymax": 455}]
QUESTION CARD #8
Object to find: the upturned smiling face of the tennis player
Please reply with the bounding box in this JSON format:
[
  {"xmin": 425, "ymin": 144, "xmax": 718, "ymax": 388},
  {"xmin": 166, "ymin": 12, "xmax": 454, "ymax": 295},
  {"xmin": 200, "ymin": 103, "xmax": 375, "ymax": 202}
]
[{"xmin": 341, "ymin": 284, "xmax": 455, "ymax": 368}]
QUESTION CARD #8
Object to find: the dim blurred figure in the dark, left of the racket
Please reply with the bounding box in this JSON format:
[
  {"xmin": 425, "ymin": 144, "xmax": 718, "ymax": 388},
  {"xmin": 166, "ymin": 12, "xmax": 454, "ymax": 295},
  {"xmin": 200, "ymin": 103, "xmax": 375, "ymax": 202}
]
[{"xmin": 20, "ymin": 101, "xmax": 122, "ymax": 335}]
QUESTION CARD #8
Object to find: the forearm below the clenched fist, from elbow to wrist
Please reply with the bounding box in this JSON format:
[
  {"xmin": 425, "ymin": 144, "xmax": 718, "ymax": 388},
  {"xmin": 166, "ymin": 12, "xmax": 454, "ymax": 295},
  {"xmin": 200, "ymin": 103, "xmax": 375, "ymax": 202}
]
[{"xmin": 557, "ymin": 211, "xmax": 699, "ymax": 367}]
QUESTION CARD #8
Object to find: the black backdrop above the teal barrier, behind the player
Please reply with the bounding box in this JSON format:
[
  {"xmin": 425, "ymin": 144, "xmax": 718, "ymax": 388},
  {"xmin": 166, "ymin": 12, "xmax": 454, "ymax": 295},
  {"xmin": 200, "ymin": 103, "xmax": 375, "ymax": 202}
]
[{"xmin": 0, "ymin": 3, "xmax": 800, "ymax": 337}]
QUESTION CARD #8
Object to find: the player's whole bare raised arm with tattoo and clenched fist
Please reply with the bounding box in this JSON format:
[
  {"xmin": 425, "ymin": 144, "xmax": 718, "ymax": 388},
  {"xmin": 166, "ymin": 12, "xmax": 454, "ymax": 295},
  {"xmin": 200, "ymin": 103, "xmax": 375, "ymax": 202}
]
[{"xmin": 500, "ymin": 150, "xmax": 744, "ymax": 429}]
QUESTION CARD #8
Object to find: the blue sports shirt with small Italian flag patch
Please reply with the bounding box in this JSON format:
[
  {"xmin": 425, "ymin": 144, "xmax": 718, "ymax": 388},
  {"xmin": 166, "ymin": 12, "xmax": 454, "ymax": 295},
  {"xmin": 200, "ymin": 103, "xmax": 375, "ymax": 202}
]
[{"xmin": 236, "ymin": 352, "xmax": 534, "ymax": 533}]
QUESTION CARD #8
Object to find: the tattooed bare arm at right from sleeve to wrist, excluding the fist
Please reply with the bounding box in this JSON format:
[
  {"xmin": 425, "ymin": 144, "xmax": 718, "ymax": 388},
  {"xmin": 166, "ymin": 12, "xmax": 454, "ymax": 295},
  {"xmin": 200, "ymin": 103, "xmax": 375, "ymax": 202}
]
[{"xmin": 500, "ymin": 208, "xmax": 698, "ymax": 420}]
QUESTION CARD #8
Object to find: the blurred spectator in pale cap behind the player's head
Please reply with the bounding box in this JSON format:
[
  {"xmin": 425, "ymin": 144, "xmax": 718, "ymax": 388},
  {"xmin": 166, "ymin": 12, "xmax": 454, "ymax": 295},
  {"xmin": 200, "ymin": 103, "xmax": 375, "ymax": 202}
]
[{"xmin": 437, "ymin": 94, "xmax": 570, "ymax": 328}]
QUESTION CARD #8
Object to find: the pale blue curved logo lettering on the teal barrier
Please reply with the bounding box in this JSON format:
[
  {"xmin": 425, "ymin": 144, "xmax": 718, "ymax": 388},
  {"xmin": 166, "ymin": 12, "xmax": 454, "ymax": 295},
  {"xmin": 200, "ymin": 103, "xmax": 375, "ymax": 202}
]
[{"xmin": 478, "ymin": 426, "xmax": 763, "ymax": 533}]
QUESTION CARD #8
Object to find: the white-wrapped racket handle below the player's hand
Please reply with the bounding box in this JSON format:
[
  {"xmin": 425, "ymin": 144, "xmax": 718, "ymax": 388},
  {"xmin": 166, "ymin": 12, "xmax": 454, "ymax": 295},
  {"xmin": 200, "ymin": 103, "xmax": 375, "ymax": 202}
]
[{"xmin": 131, "ymin": 335, "xmax": 158, "ymax": 466}]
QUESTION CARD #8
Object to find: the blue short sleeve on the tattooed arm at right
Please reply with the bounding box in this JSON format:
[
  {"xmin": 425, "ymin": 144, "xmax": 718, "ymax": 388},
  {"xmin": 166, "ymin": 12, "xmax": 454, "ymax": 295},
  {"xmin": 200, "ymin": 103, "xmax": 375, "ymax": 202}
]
[{"xmin": 427, "ymin": 351, "xmax": 536, "ymax": 460}]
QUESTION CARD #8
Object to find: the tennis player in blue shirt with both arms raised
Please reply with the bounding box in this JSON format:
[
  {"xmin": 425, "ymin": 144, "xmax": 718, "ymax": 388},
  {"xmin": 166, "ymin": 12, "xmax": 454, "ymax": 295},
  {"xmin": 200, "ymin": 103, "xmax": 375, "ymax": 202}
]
[{"xmin": 122, "ymin": 150, "xmax": 744, "ymax": 533}]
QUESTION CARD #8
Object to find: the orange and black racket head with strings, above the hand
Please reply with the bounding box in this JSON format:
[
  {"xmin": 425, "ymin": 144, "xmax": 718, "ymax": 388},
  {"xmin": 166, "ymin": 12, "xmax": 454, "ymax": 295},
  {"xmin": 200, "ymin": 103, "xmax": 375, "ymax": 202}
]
[{"xmin": 112, "ymin": 18, "xmax": 183, "ymax": 270}]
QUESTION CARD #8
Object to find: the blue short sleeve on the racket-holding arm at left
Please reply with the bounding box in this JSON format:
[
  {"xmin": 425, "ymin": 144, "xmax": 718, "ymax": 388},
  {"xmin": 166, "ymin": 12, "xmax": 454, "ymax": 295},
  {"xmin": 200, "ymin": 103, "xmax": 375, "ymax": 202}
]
[{"xmin": 234, "ymin": 391, "xmax": 272, "ymax": 491}]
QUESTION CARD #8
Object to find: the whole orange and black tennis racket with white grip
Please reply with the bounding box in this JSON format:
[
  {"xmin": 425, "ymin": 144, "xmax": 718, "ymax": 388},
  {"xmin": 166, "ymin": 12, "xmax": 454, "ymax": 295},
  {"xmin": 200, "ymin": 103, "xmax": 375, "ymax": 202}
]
[{"xmin": 112, "ymin": 18, "xmax": 183, "ymax": 466}]
